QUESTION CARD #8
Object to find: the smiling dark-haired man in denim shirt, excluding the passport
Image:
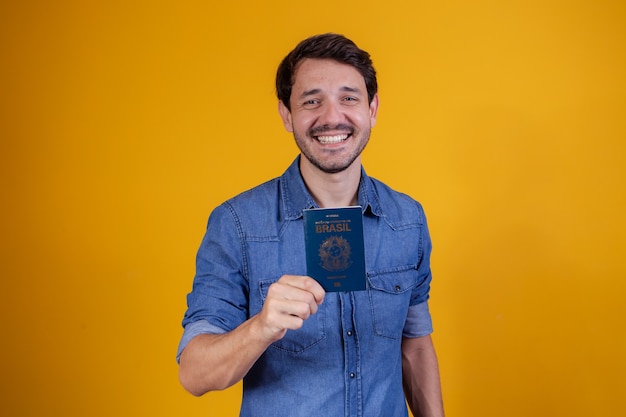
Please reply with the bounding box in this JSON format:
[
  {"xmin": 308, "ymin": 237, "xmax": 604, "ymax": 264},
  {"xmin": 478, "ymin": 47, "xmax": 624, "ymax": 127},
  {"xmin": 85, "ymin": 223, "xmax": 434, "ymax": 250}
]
[{"xmin": 178, "ymin": 34, "xmax": 443, "ymax": 417}]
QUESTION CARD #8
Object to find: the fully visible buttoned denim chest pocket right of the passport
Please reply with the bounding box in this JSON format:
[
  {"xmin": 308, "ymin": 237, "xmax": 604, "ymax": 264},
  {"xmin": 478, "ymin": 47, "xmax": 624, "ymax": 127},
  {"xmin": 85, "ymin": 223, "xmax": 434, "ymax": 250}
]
[{"xmin": 367, "ymin": 265, "xmax": 418, "ymax": 339}]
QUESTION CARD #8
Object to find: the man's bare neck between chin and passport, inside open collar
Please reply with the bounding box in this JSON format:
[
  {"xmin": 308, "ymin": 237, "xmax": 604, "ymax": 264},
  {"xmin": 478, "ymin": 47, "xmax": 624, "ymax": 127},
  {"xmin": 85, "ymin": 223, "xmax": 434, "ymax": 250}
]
[{"xmin": 300, "ymin": 156, "xmax": 361, "ymax": 208}]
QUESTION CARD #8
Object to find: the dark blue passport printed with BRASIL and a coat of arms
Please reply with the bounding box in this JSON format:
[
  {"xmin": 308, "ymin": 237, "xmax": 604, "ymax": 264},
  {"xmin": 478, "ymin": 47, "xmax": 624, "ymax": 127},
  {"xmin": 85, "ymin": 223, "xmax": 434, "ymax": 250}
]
[{"xmin": 304, "ymin": 206, "xmax": 366, "ymax": 292}]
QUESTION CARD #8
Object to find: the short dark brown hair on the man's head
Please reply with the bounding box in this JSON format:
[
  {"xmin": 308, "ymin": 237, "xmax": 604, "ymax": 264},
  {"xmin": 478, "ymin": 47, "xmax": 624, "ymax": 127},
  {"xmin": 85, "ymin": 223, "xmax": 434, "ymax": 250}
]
[{"xmin": 276, "ymin": 33, "xmax": 378, "ymax": 110}]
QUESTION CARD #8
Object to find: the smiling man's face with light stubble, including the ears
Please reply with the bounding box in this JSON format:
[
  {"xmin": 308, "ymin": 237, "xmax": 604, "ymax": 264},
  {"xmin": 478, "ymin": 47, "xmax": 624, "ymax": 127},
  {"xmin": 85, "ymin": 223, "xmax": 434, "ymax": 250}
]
[{"xmin": 279, "ymin": 59, "xmax": 378, "ymax": 173}]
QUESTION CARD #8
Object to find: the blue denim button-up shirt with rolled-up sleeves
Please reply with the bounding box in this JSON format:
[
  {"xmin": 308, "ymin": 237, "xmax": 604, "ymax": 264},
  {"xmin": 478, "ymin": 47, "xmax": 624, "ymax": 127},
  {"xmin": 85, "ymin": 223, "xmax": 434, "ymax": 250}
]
[{"xmin": 178, "ymin": 157, "xmax": 432, "ymax": 417}]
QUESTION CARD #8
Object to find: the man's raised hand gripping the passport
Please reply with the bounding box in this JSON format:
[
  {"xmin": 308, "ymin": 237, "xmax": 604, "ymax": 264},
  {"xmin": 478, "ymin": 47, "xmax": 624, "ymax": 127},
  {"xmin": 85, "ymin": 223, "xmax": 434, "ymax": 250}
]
[{"xmin": 257, "ymin": 275, "xmax": 326, "ymax": 343}]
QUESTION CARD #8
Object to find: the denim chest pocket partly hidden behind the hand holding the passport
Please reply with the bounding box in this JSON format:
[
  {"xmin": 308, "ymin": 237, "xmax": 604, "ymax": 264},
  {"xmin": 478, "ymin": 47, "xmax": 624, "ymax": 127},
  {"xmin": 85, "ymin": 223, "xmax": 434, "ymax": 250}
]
[{"xmin": 259, "ymin": 280, "xmax": 326, "ymax": 353}]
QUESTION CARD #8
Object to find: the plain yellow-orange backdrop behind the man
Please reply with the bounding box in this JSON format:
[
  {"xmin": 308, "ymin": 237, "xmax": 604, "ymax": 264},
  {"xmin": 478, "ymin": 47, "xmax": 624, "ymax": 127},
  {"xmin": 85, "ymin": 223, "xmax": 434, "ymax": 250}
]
[{"xmin": 0, "ymin": 0, "xmax": 626, "ymax": 417}]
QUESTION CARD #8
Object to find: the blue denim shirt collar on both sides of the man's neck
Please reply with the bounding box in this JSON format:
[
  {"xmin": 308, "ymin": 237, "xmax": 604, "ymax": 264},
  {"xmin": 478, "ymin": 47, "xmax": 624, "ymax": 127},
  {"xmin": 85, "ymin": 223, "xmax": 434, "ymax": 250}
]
[{"xmin": 280, "ymin": 155, "xmax": 384, "ymax": 220}]
